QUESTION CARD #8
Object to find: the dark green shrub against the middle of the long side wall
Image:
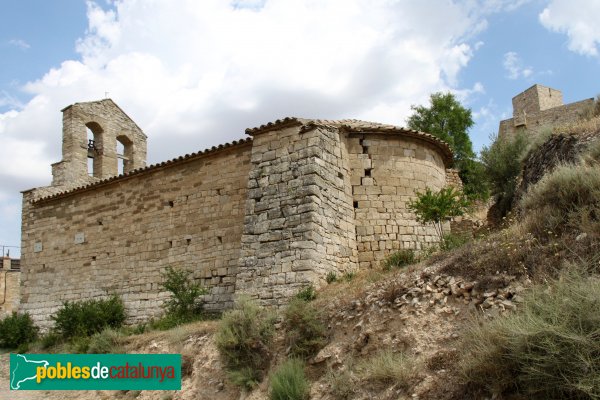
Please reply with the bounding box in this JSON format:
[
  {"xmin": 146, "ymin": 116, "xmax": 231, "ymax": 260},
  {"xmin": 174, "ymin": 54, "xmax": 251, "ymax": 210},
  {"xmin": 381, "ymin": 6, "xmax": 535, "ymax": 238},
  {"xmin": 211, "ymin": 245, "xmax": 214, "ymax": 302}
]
[{"xmin": 161, "ymin": 266, "xmax": 207, "ymax": 319}]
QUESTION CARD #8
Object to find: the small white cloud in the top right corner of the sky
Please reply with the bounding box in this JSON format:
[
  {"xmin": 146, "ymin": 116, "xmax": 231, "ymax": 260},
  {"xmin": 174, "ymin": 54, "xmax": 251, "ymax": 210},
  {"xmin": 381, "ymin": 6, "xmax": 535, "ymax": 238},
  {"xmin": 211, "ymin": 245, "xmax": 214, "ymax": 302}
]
[{"xmin": 539, "ymin": 0, "xmax": 600, "ymax": 56}]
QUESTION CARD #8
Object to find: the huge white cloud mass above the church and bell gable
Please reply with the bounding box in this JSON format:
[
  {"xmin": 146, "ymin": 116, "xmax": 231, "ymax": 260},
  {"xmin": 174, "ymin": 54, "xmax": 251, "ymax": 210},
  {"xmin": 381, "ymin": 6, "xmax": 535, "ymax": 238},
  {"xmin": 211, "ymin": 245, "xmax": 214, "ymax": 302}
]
[{"xmin": 0, "ymin": 0, "xmax": 512, "ymax": 247}]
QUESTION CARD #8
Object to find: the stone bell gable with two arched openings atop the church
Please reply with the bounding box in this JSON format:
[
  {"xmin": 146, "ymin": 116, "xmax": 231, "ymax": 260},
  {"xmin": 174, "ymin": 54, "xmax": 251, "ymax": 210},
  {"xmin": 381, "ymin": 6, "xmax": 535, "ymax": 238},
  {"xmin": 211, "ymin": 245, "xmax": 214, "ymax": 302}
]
[{"xmin": 52, "ymin": 99, "xmax": 147, "ymax": 188}]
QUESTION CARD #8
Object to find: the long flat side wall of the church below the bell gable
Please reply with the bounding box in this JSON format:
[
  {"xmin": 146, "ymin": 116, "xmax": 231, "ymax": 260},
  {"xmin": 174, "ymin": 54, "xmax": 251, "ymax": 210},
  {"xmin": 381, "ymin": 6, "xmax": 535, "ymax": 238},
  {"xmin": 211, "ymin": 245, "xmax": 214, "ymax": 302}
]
[{"xmin": 21, "ymin": 141, "xmax": 252, "ymax": 327}]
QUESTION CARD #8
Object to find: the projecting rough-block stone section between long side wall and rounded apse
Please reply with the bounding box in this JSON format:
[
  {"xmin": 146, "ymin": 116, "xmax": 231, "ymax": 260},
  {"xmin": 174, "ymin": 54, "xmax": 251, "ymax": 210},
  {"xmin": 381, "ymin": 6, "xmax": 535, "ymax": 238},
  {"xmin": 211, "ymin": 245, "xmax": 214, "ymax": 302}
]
[{"xmin": 236, "ymin": 123, "xmax": 356, "ymax": 305}]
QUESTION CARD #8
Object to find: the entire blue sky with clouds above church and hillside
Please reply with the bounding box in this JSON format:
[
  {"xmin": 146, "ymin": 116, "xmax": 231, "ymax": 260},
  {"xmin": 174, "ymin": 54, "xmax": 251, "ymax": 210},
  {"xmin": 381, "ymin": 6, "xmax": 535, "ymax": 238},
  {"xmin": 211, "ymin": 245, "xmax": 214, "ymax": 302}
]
[{"xmin": 0, "ymin": 0, "xmax": 600, "ymax": 254}]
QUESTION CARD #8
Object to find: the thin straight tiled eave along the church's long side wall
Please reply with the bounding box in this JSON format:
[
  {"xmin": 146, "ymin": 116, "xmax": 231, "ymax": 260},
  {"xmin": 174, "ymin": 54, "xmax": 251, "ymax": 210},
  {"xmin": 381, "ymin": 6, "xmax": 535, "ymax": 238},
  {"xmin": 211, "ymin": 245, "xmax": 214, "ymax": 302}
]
[{"xmin": 32, "ymin": 138, "xmax": 252, "ymax": 203}]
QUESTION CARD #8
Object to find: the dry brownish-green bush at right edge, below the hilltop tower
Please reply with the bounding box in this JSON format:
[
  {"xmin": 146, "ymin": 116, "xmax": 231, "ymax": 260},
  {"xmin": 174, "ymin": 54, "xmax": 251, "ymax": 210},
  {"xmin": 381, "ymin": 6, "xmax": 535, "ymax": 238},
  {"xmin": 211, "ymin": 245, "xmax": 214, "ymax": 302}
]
[{"xmin": 521, "ymin": 164, "xmax": 600, "ymax": 237}]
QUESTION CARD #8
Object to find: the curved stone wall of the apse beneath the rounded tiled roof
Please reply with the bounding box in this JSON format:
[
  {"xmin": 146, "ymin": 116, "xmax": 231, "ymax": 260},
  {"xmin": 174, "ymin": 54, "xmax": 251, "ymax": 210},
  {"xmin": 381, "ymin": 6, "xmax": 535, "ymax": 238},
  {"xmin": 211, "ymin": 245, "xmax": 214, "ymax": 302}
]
[{"xmin": 347, "ymin": 133, "xmax": 446, "ymax": 268}]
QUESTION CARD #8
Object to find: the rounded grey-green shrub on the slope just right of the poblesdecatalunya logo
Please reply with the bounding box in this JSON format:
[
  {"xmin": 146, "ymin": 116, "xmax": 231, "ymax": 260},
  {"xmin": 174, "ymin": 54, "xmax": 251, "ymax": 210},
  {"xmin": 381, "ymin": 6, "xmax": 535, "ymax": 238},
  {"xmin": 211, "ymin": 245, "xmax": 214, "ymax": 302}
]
[{"xmin": 215, "ymin": 297, "xmax": 275, "ymax": 388}]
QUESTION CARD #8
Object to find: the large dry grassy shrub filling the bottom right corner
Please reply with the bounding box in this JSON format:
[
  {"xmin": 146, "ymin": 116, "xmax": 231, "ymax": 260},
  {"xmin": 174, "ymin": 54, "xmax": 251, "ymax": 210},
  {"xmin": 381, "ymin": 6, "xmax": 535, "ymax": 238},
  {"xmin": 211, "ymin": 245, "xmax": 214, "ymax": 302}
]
[{"xmin": 460, "ymin": 276, "xmax": 600, "ymax": 399}]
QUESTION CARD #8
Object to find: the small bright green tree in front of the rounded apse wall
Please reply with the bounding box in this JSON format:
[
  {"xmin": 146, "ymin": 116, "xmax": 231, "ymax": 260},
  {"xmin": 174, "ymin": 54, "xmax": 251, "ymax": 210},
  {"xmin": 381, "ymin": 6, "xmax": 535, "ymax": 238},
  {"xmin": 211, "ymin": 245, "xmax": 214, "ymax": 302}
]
[{"xmin": 408, "ymin": 187, "xmax": 469, "ymax": 242}]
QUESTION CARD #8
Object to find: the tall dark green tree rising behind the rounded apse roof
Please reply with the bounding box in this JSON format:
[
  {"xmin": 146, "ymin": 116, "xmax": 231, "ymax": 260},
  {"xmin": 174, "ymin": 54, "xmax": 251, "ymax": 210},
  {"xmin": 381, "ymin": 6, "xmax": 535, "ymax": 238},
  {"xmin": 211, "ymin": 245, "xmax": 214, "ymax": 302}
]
[{"xmin": 406, "ymin": 92, "xmax": 475, "ymax": 164}]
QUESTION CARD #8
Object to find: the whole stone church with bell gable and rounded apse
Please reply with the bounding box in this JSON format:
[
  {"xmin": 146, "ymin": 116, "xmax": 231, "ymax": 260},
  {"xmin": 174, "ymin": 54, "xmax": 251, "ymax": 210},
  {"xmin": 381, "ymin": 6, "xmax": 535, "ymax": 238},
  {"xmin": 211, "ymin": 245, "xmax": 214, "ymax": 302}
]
[{"xmin": 20, "ymin": 99, "xmax": 459, "ymax": 327}]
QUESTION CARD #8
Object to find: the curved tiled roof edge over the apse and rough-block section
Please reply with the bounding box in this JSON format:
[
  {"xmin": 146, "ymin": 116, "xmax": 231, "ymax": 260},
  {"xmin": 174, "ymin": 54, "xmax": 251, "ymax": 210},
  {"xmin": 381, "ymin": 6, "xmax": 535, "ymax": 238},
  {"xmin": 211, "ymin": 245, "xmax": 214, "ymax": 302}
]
[{"xmin": 246, "ymin": 117, "xmax": 453, "ymax": 164}]
